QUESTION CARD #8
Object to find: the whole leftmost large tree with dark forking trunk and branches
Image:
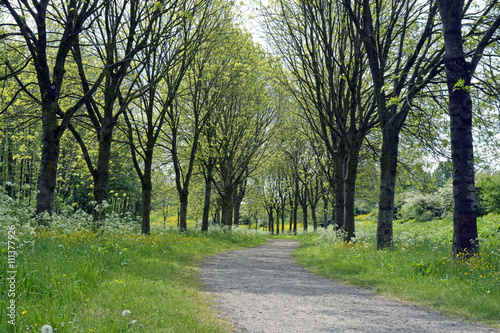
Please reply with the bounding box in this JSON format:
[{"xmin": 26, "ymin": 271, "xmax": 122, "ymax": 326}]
[{"xmin": 0, "ymin": 0, "xmax": 103, "ymax": 224}]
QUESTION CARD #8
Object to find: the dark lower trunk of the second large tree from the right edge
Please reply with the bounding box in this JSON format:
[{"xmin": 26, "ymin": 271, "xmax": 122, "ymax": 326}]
[{"xmin": 376, "ymin": 126, "xmax": 399, "ymax": 249}]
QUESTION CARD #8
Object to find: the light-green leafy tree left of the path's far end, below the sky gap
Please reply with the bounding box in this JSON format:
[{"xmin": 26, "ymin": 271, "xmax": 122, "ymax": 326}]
[{"xmin": 214, "ymin": 42, "xmax": 279, "ymax": 226}]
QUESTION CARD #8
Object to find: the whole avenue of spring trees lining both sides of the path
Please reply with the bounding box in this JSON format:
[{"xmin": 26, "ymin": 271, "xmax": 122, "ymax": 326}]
[{"xmin": 0, "ymin": 0, "xmax": 500, "ymax": 255}]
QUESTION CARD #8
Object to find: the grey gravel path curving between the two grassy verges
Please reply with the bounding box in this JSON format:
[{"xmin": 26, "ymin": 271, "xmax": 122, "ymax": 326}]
[{"xmin": 201, "ymin": 240, "xmax": 498, "ymax": 333}]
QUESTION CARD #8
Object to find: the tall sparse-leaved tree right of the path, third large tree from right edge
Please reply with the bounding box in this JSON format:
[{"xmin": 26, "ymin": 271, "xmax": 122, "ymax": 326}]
[{"xmin": 266, "ymin": 1, "xmax": 376, "ymax": 240}]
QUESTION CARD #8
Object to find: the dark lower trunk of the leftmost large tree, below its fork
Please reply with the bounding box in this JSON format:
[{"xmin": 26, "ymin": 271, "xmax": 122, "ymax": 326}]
[{"xmin": 35, "ymin": 102, "xmax": 61, "ymax": 225}]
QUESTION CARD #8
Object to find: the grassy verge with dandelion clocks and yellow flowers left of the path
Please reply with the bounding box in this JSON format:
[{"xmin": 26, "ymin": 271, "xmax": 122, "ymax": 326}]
[{"xmin": 0, "ymin": 218, "xmax": 264, "ymax": 333}]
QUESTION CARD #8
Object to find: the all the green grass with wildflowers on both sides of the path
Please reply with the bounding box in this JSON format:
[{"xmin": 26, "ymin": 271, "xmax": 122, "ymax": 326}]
[{"xmin": 0, "ymin": 209, "xmax": 500, "ymax": 333}]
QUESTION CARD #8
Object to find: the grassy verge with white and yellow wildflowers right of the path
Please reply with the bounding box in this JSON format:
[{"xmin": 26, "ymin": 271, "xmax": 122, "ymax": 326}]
[{"xmin": 294, "ymin": 215, "xmax": 500, "ymax": 327}]
